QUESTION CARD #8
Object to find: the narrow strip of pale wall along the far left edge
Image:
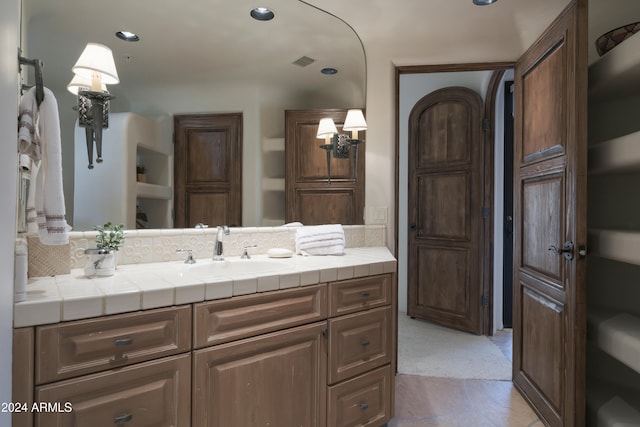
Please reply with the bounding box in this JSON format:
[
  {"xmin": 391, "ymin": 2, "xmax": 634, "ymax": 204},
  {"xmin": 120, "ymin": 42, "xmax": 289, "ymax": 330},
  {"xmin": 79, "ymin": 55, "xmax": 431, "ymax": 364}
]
[{"xmin": 0, "ymin": 0, "xmax": 20, "ymax": 426}]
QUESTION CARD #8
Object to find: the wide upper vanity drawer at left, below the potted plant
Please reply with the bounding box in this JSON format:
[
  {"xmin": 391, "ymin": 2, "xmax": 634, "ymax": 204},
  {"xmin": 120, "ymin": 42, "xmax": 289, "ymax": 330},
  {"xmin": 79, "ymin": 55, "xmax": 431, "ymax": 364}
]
[{"xmin": 36, "ymin": 305, "xmax": 191, "ymax": 384}]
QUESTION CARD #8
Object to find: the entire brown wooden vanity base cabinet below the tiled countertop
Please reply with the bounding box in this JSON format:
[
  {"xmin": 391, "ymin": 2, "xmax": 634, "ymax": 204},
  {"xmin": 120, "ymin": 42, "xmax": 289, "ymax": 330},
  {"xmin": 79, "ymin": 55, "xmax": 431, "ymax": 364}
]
[{"xmin": 12, "ymin": 273, "xmax": 397, "ymax": 427}]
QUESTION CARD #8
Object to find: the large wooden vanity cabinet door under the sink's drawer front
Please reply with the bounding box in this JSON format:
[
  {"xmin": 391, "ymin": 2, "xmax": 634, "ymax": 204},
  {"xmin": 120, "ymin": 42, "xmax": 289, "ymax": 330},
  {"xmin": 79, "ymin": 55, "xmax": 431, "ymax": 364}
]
[{"xmin": 192, "ymin": 322, "xmax": 327, "ymax": 427}]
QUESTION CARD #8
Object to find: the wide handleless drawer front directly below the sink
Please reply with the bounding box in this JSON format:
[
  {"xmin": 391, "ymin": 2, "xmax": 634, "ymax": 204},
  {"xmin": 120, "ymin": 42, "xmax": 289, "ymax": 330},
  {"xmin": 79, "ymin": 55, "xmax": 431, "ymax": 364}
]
[{"xmin": 193, "ymin": 284, "xmax": 327, "ymax": 348}]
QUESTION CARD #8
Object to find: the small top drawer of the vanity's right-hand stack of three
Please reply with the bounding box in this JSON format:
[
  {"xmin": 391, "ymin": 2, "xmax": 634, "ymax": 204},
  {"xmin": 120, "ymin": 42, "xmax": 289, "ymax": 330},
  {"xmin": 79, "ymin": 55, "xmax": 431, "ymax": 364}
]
[{"xmin": 329, "ymin": 274, "xmax": 391, "ymax": 317}]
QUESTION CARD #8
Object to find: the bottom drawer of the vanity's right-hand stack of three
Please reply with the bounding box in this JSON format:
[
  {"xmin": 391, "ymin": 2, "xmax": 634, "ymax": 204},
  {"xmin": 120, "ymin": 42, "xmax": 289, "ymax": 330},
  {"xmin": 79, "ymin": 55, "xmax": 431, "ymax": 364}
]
[{"xmin": 327, "ymin": 365, "xmax": 393, "ymax": 427}]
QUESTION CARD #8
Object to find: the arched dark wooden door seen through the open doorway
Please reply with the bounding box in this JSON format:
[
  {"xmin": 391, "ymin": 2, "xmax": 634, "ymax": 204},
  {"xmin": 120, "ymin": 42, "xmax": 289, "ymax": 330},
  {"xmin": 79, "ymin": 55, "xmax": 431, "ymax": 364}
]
[{"xmin": 407, "ymin": 87, "xmax": 484, "ymax": 334}]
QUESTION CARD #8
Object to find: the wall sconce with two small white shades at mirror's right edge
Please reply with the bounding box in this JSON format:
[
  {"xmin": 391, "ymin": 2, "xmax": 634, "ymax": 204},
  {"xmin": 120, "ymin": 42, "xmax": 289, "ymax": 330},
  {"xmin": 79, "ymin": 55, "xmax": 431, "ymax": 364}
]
[{"xmin": 316, "ymin": 109, "xmax": 367, "ymax": 185}]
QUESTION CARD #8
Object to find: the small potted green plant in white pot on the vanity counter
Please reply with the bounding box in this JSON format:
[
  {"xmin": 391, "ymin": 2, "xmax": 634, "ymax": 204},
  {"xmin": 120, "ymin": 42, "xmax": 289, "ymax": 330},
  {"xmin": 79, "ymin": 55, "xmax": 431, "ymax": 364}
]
[{"xmin": 84, "ymin": 222, "xmax": 125, "ymax": 277}]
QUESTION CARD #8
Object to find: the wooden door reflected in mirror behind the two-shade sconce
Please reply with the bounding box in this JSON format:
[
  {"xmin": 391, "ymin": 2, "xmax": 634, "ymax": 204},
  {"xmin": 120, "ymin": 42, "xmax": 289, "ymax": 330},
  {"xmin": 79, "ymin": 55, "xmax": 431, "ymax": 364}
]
[{"xmin": 285, "ymin": 110, "xmax": 366, "ymax": 225}]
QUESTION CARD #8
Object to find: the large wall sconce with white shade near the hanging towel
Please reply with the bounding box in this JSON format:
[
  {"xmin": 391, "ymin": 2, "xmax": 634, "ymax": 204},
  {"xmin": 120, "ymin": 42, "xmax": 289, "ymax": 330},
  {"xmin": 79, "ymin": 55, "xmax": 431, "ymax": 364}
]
[{"xmin": 67, "ymin": 43, "xmax": 120, "ymax": 169}]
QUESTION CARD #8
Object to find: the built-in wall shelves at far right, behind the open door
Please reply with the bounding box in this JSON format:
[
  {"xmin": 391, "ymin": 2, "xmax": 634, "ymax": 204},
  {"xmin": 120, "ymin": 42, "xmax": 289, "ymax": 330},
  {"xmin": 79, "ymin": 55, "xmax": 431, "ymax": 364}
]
[{"xmin": 586, "ymin": 26, "xmax": 640, "ymax": 426}]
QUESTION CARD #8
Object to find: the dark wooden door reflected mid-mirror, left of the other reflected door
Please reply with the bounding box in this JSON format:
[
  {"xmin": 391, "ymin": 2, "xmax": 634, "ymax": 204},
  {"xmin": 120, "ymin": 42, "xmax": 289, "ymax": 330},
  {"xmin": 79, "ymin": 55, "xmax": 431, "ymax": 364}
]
[{"xmin": 174, "ymin": 113, "xmax": 242, "ymax": 228}]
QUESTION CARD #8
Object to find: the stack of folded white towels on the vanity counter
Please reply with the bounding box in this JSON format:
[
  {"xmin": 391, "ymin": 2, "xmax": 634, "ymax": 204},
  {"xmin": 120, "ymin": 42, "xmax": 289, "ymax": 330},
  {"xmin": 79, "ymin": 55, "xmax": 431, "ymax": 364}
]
[{"xmin": 296, "ymin": 224, "xmax": 345, "ymax": 255}]
